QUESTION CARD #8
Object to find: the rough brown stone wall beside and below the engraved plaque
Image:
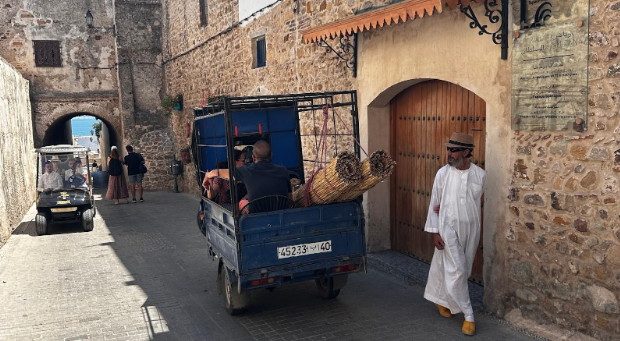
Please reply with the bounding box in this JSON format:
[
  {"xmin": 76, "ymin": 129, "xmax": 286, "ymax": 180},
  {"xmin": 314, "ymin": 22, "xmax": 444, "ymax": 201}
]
[{"xmin": 494, "ymin": 0, "xmax": 620, "ymax": 340}]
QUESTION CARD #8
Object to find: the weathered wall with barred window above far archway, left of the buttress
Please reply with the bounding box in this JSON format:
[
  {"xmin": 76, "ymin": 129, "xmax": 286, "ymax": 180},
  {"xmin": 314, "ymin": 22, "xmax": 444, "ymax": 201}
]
[{"xmin": 0, "ymin": 0, "xmax": 121, "ymax": 146}]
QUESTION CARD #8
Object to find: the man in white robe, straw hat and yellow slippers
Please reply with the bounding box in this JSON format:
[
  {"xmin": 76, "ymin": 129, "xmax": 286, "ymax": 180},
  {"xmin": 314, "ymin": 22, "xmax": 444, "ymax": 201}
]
[{"xmin": 424, "ymin": 133, "xmax": 486, "ymax": 335}]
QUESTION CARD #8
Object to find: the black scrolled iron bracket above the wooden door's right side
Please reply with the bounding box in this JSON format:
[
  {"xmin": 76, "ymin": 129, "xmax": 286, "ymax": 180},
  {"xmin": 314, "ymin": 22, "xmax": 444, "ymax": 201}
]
[{"xmin": 459, "ymin": 0, "xmax": 508, "ymax": 60}]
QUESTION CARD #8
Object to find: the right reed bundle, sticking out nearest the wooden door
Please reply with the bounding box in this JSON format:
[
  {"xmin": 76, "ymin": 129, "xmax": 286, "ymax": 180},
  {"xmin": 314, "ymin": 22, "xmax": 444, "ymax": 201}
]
[{"xmin": 337, "ymin": 150, "xmax": 396, "ymax": 202}]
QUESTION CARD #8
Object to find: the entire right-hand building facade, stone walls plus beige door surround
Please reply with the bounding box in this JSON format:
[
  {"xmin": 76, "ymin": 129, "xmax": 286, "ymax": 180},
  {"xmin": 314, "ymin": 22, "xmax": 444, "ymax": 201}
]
[{"xmin": 163, "ymin": 0, "xmax": 620, "ymax": 340}]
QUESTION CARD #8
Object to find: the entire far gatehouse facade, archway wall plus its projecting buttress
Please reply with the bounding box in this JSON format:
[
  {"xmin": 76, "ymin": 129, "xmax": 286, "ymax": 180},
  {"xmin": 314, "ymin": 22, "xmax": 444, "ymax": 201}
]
[{"xmin": 0, "ymin": 0, "xmax": 172, "ymax": 189}]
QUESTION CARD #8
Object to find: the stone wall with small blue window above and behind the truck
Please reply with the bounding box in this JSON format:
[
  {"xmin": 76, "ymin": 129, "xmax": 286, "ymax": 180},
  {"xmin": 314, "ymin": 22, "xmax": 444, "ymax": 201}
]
[{"xmin": 164, "ymin": 0, "xmax": 388, "ymax": 194}]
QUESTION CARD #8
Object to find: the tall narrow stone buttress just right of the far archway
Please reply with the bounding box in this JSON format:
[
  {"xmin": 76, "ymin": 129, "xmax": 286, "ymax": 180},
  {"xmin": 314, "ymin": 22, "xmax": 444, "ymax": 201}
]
[{"xmin": 115, "ymin": 0, "xmax": 173, "ymax": 189}]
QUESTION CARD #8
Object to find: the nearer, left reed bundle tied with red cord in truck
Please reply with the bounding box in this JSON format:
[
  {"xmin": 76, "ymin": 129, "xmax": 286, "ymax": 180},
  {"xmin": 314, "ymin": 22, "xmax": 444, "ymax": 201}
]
[{"xmin": 293, "ymin": 152, "xmax": 362, "ymax": 207}]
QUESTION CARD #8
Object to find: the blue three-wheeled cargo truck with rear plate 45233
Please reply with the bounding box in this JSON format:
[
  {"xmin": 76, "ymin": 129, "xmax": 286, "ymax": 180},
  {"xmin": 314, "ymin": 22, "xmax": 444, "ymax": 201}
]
[{"xmin": 192, "ymin": 91, "xmax": 366, "ymax": 314}]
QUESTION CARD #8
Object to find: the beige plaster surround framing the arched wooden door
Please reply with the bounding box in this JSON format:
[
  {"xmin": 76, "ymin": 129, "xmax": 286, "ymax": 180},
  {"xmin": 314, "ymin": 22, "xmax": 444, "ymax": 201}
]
[{"xmin": 357, "ymin": 8, "xmax": 510, "ymax": 298}]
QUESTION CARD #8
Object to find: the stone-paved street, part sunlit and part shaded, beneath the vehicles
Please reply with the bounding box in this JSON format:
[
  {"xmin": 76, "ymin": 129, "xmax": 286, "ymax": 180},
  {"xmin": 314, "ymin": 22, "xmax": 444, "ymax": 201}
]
[{"xmin": 0, "ymin": 192, "xmax": 530, "ymax": 340}]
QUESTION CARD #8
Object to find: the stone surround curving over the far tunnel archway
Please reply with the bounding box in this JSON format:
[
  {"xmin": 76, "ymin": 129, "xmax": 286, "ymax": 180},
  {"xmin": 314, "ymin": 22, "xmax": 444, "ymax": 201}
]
[{"xmin": 33, "ymin": 98, "xmax": 123, "ymax": 145}]
